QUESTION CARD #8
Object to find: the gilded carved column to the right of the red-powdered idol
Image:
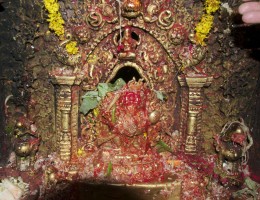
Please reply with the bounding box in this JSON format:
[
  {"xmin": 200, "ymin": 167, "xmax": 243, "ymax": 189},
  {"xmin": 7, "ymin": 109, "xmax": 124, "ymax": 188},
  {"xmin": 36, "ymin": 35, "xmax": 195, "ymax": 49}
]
[{"xmin": 178, "ymin": 75, "xmax": 212, "ymax": 154}]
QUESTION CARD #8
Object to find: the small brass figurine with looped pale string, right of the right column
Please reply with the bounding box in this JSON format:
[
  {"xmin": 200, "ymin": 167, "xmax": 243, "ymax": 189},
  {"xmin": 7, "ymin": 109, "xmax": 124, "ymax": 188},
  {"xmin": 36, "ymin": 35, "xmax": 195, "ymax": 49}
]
[{"xmin": 215, "ymin": 119, "xmax": 253, "ymax": 185}]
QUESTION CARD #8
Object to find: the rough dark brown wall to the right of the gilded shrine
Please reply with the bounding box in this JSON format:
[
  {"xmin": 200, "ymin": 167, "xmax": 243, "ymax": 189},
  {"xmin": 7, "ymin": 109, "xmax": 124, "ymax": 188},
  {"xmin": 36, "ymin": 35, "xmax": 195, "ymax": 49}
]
[{"xmin": 202, "ymin": 1, "xmax": 260, "ymax": 173}]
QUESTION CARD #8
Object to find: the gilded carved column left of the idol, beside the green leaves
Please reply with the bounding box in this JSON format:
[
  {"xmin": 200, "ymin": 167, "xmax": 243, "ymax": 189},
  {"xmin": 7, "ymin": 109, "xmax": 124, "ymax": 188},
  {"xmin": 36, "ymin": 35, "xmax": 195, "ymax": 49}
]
[{"xmin": 54, "ymin": 76, "xmax": 76, "ymax": 160}]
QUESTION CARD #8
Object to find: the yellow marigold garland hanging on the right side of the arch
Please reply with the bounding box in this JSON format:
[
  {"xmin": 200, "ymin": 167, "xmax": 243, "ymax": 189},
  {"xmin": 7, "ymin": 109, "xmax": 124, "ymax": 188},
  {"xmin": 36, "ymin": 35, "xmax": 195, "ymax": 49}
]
[{"xmin": 195, "ymin": 0, "xmax": 220, "ymax": 46}]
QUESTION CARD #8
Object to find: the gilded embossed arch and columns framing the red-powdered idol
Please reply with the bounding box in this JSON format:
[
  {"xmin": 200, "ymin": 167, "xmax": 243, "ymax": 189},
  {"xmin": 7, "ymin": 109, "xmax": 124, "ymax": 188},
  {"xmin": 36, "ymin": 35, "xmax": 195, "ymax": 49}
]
[{"xmin": 50, "ymin": 0, "xmax": 211, "ymax": 160}]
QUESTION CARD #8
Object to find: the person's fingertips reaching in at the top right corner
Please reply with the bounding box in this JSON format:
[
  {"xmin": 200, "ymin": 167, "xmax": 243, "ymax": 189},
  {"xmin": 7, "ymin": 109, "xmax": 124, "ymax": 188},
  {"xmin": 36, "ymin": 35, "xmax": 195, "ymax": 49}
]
[{"xmin": 238, "ymin": 2, "xmax": 260, "ymax": 24}]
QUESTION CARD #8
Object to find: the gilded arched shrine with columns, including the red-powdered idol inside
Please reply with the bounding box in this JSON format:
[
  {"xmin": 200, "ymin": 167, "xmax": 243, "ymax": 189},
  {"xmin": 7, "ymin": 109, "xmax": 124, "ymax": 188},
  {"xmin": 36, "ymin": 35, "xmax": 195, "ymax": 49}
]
[{"xmin": 50, "ymin": 0, "xmax": 212, "ymax": 182}]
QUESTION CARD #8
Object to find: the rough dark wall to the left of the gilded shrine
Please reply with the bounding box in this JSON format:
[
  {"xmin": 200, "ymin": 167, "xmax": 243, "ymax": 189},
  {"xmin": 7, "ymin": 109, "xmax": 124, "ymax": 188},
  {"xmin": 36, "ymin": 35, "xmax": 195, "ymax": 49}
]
[{"xmin": 0, "ymin": 0, "xmax": 53, "ymax": 163}]
